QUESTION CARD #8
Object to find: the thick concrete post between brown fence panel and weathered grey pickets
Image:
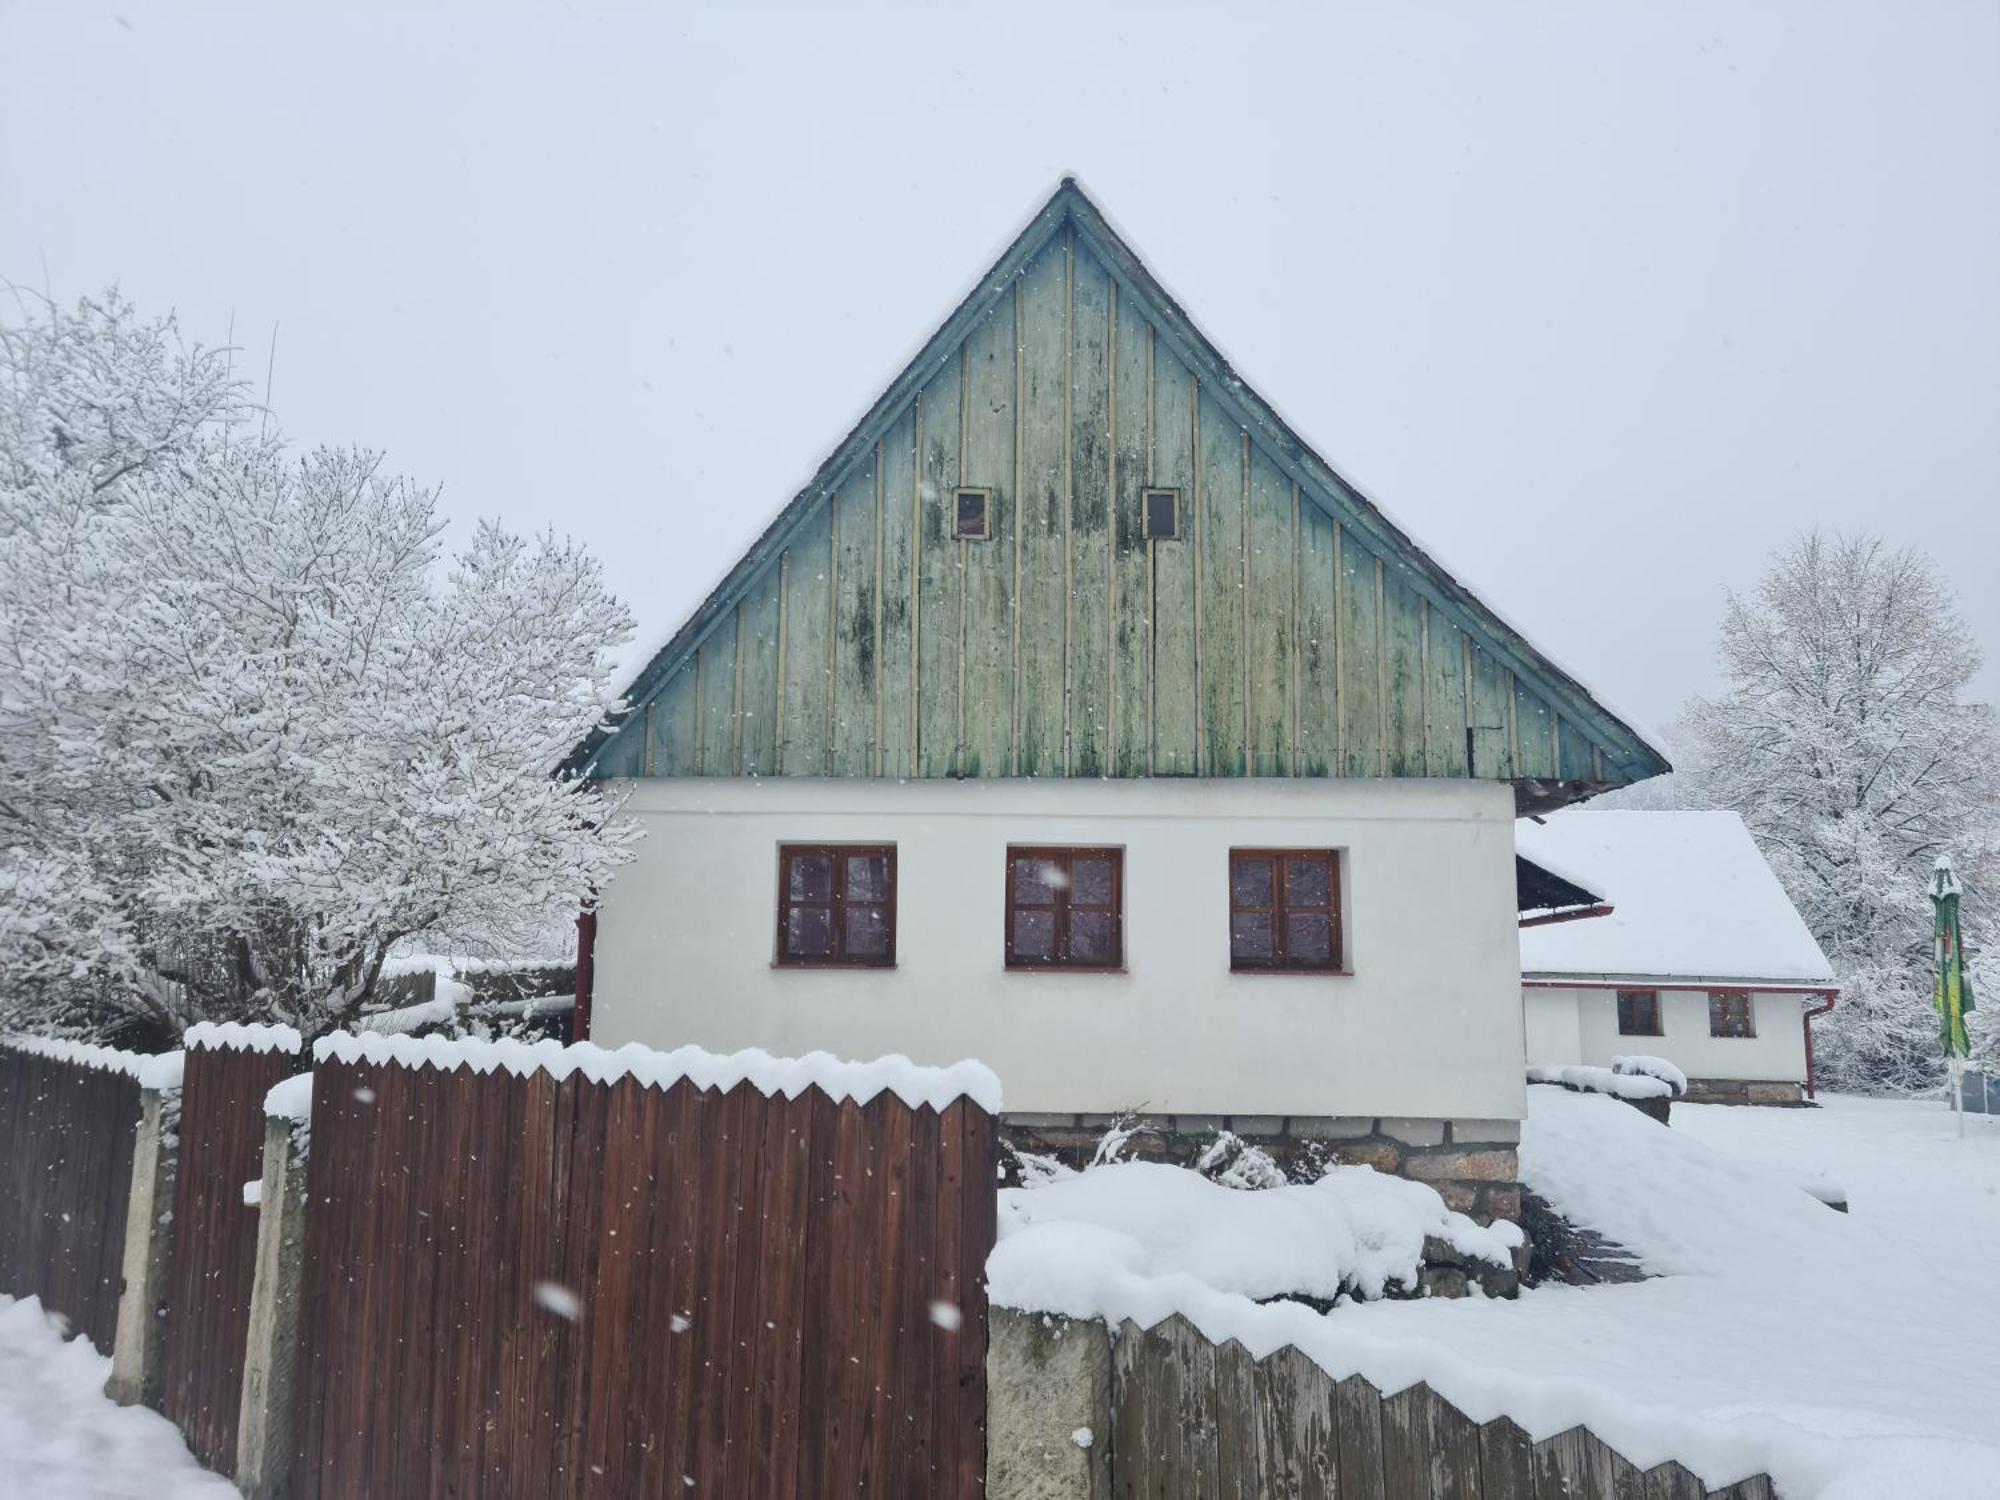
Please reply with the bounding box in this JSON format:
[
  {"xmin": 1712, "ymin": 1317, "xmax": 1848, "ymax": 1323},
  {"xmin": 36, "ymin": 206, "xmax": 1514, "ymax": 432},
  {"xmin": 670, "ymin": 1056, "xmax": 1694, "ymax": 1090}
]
[{"xmin": 986, "ymin": 1308, "xmax": 1112, "ymax": 1500}]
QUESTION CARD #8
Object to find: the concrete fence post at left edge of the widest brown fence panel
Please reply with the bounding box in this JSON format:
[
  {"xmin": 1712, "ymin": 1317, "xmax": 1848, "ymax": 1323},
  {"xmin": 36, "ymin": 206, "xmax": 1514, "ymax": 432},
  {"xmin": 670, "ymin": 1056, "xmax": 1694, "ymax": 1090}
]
[{"xmin": 236, "ymin": 1116, "xmax": 306, "ymax": 1500}]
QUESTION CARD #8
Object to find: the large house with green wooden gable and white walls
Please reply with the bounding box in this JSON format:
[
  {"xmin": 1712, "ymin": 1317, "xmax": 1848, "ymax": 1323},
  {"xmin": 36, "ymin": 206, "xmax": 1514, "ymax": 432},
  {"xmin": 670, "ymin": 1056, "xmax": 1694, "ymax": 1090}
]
[{"xmin": 570, "ymin": 182, "xmax": 1666, "ymax": 1212}]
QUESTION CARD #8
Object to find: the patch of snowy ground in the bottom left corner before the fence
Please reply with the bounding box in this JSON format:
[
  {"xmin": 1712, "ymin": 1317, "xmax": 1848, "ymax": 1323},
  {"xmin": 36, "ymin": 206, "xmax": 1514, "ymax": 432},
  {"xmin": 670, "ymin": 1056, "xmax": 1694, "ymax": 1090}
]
[{"xmin": 0, "ymin": 1296, "xmax": 236, "ymax": 1500}]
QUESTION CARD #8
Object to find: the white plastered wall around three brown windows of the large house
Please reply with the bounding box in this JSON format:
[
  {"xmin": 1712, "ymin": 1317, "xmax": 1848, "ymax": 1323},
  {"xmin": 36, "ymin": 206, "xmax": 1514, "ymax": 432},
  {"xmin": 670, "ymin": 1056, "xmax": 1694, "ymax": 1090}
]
[{"xmin": 592, "ymin": 778, "xmax": 1524, "ymax": 1118}]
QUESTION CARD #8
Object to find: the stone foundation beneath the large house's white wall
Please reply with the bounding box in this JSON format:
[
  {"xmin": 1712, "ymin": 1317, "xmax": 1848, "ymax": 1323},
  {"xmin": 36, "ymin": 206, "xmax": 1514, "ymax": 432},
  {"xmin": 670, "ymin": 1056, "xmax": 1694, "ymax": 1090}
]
[{"xmin": 1002, "ymin": 1114, "xmax": 1520, "ymax": 1224}]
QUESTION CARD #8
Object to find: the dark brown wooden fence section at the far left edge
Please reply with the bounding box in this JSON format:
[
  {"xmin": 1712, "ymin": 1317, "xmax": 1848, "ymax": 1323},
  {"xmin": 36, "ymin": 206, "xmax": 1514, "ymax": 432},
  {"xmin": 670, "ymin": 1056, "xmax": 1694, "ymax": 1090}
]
[{"xmin": 0, "ymin": 1048, "xmax": 138, "ymax": 1354}]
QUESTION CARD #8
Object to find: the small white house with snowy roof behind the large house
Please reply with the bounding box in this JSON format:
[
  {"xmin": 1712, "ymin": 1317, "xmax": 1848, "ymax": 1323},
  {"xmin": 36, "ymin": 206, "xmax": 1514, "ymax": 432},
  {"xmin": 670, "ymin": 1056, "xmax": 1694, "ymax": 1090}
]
[{"xmin": 1516, "ymin": 808, "xmax": 1838, "ymax": 1104}]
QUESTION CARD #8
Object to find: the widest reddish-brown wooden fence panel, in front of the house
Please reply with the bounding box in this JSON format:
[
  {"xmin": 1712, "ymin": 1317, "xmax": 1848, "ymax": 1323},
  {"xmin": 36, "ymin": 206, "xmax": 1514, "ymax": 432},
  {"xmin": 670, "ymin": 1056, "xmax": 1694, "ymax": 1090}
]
[{"xmin": 292, "ymin": 1060, "xmax": 996, "ymax": 1500}]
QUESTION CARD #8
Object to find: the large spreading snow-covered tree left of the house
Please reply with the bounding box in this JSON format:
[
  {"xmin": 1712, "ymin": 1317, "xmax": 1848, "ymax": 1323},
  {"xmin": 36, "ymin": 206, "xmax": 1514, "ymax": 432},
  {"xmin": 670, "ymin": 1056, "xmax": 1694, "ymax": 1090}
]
[{"xmin": 0, "ymin": 296, "xmax": 630, "ymax": 1036}]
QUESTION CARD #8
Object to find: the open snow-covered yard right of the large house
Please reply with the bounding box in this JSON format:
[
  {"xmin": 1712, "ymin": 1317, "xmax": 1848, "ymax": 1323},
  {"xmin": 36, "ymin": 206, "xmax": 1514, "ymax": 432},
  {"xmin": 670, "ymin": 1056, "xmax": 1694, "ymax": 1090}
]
[{"xmin": 1334, "ymin": 1088, "xmax": 2000, "ymax": 1500}]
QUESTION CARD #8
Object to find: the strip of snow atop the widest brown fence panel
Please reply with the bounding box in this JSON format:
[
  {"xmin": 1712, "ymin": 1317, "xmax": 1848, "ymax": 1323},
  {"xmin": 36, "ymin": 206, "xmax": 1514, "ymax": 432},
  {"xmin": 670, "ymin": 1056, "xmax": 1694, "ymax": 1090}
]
[{"xmin": 312, "ymin": 1032, "xmax": 1002, "ymax": 1114}]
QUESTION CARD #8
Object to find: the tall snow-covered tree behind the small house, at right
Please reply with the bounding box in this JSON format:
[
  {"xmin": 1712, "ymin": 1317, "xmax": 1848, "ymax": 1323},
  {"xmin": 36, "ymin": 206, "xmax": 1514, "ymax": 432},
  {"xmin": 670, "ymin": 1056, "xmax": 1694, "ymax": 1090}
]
[{"xmin": 1684, "ymin": 534, "xmax": 2000, "ymax": 1090}]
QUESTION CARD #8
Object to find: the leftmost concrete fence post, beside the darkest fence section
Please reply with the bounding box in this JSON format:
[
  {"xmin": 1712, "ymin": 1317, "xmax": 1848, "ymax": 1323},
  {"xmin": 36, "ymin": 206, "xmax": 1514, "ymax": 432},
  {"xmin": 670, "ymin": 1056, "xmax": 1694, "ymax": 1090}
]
[{"xmin": 104, "ymin": 1088, "xmax": 180, "ymax": 1410}]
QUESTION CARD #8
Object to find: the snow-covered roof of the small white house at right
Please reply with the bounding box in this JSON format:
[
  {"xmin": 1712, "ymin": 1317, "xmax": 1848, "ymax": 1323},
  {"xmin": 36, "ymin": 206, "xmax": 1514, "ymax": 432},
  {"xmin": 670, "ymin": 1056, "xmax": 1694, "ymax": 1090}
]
[{"xmin": 1514, "ymin": 808, "xmax": 1832, "ymax": 984}]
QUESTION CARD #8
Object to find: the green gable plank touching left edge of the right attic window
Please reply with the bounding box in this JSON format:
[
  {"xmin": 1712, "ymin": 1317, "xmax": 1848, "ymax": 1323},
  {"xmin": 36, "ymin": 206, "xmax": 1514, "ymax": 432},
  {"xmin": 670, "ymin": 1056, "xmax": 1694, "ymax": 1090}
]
[{"xmin": 1092, "ymin": 284, "xmax": 1160, "ymax": 776}]
